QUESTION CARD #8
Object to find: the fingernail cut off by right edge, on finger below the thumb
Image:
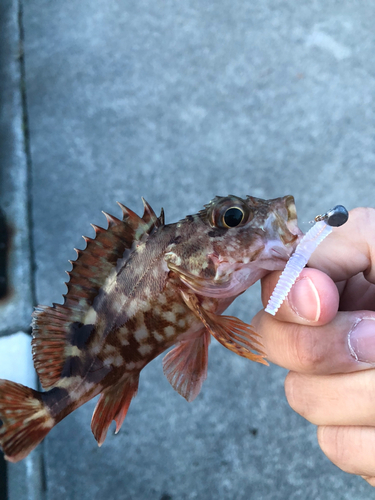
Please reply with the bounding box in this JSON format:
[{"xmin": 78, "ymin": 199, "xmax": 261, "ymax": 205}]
[{"xmin": 348, "ymin": 318, "xmax": 375, "ymax": 363}]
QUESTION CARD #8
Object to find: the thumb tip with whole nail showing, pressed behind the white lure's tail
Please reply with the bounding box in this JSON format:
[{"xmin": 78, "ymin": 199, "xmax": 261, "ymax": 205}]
[{"xmin": 262, "ymin": 268, "xmax": 339, "ymax": 325}]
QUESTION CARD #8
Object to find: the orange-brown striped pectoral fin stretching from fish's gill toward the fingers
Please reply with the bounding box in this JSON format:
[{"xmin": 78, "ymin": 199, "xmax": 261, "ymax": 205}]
[{"xmin": 181, "ymin": 290, "xmax": 268, "ymax": 365}]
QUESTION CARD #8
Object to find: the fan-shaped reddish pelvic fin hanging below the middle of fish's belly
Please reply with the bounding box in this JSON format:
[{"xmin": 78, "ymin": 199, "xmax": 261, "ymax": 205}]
[{"xmin": 163, "ymin": 328, "xmax": 210, "ymax": 403}]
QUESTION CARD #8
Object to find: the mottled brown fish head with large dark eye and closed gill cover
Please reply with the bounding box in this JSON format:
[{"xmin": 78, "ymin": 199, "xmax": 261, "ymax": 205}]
[{"xmin": 165, "ymin": 195, "xmax": 303, "ymax": 297}]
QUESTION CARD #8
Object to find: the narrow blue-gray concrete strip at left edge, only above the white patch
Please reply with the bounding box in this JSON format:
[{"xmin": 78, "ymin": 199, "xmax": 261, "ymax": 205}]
[{"xmin": 0, "ymin": 0, "xmax": 33, "ymax": 335}]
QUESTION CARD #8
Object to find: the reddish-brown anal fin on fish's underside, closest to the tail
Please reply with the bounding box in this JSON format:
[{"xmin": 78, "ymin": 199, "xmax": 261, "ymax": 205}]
[{"xmin": 91, "ymin": 374, "xmax": 139, "ymax": 446}]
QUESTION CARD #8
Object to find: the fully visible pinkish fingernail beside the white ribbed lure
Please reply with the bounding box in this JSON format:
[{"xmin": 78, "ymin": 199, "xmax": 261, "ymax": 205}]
[{"xmin": 288, "ymin": 277, "xmax": 320, "ymax": 321}]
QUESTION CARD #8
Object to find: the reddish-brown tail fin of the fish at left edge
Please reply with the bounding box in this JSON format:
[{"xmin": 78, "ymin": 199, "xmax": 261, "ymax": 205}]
[{"xmin": 0, "ymin": 380, "xmax": 55, "ymax": 462}]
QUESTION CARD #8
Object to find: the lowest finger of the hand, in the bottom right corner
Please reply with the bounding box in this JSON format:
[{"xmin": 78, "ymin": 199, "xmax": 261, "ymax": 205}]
[{"xmin": 318, "ymin": 426, "xmax": 375, "ymax": 478}]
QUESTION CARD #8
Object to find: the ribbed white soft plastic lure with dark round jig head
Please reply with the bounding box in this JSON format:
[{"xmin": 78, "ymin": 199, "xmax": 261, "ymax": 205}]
[{"xmin": 265, "ymin": 205, "xmax": 349, "ymax": 316}]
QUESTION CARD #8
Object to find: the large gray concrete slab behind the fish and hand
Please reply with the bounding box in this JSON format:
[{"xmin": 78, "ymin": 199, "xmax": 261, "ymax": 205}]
[{"xmin": 2, "ymin": 0, "xmax": 375, "ymax": 500}]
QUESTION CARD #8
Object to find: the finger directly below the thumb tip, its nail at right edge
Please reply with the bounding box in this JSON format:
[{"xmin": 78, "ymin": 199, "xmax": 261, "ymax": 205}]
[{"xmin": 252, "ymin": 311, "xmax": 375, "ymax": 375}]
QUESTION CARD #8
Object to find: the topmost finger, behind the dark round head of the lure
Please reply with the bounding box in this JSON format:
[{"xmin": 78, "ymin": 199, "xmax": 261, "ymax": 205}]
[{"xmin": 309, "ymin": 208, "xmax": 375, "ymax": 283}]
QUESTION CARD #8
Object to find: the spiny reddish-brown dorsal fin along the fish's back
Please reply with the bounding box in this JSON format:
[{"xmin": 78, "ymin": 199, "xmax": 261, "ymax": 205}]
[{"xmin": 32, "ymin": 201, "xmax": 162, "ymax": 388}]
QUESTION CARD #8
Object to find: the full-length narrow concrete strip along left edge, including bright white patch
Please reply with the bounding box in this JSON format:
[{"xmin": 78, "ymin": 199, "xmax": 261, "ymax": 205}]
[{"xmin": 0, "ymin": 0, "xmax": 43, "ymax": 500}]
